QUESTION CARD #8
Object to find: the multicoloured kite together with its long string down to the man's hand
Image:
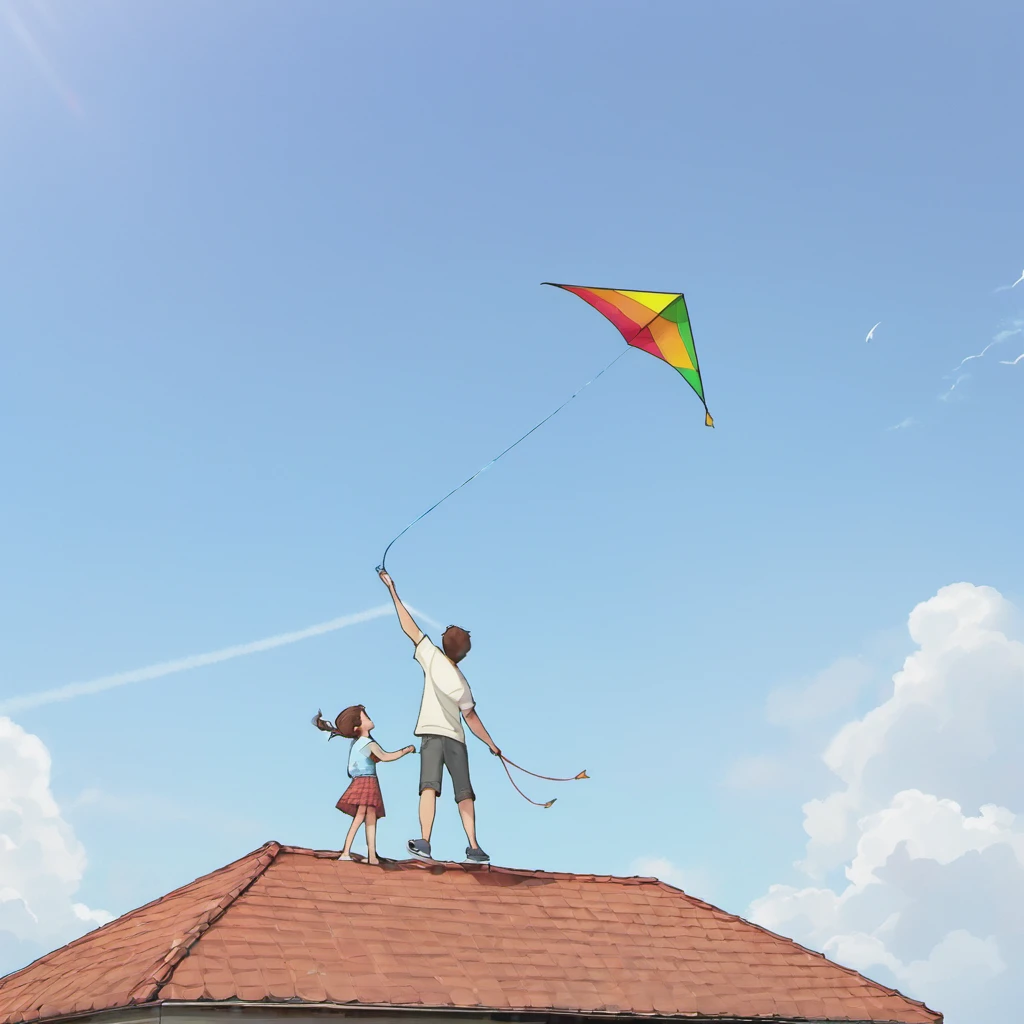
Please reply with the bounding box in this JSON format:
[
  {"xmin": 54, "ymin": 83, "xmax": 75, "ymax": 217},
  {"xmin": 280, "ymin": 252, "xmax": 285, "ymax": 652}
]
[{"xmin": 377, "ymin": 281, "xmax": 715, "ymax": 569}]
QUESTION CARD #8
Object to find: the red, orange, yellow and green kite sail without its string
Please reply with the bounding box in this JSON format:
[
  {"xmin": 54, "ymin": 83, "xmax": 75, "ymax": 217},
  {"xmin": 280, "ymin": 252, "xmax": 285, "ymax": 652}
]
[{"xmin": 544, "ymin": 281, "xmax": 715, "ymax": 427}]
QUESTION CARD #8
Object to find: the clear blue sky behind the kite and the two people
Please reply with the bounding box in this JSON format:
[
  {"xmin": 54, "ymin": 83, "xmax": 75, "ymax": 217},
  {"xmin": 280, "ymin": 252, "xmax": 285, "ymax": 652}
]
[{"xmin": 0, "ymin": 0, "xmax": 1024, "ymax": 1015}]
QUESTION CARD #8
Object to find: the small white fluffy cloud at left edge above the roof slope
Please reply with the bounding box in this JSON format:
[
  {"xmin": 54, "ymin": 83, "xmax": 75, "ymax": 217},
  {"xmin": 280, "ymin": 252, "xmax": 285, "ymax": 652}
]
[{"xmin": 0, "ymin": 717, "xmax": 111, "ymax": 948}]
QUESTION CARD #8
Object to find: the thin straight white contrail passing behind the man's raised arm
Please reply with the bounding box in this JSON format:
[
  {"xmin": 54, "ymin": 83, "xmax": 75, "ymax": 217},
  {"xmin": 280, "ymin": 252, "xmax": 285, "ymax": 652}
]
[{"xmin": 0, "ymin": 604, "xmax": 437, "ymax": 715}]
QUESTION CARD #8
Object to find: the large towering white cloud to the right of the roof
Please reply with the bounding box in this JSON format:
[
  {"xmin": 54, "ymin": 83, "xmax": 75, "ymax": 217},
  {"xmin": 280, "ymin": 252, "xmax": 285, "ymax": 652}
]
[{"xmin": 749, "ymin": 584, "xmax": 1024, "ymax": 1024}]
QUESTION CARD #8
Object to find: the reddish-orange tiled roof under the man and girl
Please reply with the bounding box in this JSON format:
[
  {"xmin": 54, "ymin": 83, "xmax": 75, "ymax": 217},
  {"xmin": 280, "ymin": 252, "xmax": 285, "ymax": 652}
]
[{"xmin": 0, "ymin": 843, "xmax": 942, "ymax": 1024}]
